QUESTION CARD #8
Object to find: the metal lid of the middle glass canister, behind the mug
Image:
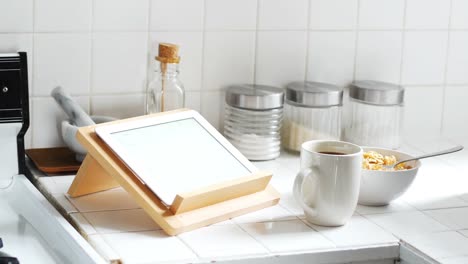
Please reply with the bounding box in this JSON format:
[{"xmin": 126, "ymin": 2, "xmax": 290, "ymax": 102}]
[{"xmin": 286, "ymin": 82, "xmax": 343, "ymax": 107}]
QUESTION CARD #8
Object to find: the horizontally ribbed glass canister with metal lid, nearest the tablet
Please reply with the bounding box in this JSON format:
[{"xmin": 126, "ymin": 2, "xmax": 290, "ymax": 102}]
[{"xmin": 224, "ymin": 85, "xmax": 284, "ymax": 160}]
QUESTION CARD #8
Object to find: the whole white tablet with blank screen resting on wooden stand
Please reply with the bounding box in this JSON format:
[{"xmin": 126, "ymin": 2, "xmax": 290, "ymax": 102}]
[{"xmin": 96, "ymin": 110, "xmax": 257, "ymax": 205}]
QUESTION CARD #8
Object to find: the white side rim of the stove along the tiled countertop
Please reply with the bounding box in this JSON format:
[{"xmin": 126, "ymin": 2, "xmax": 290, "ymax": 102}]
[{"xmin": 7, "ymin": 175, "xmax": 105, "ymax": 263}]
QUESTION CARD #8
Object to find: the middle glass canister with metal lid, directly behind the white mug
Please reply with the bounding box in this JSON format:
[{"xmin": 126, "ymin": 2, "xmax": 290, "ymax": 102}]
[{"xmin": 282, "ymin": 82, "xmax": 343, "ymax": 151}]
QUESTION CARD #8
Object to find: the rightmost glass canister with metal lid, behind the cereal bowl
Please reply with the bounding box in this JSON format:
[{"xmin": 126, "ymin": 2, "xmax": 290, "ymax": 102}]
[{"xmin": 343, "ymin": 80, "xmax": 405, "ymax": 149}]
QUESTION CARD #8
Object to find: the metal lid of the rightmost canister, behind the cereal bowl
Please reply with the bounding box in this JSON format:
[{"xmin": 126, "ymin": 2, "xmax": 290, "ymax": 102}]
[{"xmin": 349, "ymin": 80, "xmax": 405, "ymax": 105}]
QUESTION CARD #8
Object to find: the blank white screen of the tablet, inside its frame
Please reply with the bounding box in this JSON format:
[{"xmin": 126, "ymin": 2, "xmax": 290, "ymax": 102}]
[{"xmin": 111, "ymin": 118, "xmax": 251, "ymax": 205}]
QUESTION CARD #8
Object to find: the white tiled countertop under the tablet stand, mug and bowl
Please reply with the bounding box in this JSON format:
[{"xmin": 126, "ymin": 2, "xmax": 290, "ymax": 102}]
[{"xmin": 31, "ymin": 140, "xmax": 468, "ymax": 264}]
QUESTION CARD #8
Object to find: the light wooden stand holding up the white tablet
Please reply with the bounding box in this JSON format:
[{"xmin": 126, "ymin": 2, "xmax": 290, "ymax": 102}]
[{"xmin": 68, "ymin": 110, "xmax": 280, "ymax": 235}]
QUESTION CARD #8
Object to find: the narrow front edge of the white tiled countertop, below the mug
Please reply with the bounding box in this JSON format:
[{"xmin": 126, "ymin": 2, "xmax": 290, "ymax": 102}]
[{"xmin": 193, "ymin": 242, "xmax": 400, "ymax": 264}]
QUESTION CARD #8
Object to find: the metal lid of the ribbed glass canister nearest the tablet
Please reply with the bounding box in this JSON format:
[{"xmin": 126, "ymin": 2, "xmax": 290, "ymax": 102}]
[{"xmin": 226, "ymin": 84, "xmax": 284, "ymax": 110}]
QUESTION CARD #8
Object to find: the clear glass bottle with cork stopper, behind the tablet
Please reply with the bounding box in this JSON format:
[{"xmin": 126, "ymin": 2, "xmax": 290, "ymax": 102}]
[{"xmin": 146, "ymin": 43, "xmax": 185, "ymax": 114}]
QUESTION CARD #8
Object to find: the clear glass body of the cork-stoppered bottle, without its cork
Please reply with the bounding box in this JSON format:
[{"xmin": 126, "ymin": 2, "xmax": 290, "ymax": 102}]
[{"xmin": 146, "ymin": 63, "xmax": 185, "ymax": 114}]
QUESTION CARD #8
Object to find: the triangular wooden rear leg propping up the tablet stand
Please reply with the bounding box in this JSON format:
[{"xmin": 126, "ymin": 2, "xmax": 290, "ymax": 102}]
[{"xmin": 68, "ymin": 154, "xmax": 120, "ymax": 197}]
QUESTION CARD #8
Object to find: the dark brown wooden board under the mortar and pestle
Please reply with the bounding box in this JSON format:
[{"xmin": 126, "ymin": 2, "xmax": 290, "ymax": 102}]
[{"xmin": 26, "ymin": 147, "xmax": 81, "ymax": 174}]
